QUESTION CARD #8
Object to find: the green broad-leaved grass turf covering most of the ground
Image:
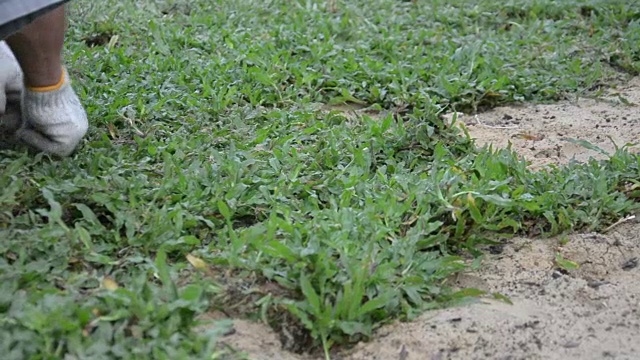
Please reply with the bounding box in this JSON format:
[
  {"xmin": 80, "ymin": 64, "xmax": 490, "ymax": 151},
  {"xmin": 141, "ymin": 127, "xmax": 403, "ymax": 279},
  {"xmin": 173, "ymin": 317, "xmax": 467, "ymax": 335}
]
[{"xmin": 0, "ymin": 0, "xmax": 640, "ymax": 359}]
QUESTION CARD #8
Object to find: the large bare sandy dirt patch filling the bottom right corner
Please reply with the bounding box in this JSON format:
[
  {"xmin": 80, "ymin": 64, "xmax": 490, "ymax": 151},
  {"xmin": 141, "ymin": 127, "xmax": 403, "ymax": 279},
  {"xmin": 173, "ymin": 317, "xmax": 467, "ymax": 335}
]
[{"xmin": 344, "ymin": 224, "xmax": 640, "ymax": 360}]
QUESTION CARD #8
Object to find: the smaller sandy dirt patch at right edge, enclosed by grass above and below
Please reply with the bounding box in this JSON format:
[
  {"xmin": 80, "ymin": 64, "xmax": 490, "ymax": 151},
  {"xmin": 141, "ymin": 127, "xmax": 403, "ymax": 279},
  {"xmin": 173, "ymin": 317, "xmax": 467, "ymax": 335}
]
[{"xmin": 445, "ymin": 78, "xmax": 640, "ymax": 169}]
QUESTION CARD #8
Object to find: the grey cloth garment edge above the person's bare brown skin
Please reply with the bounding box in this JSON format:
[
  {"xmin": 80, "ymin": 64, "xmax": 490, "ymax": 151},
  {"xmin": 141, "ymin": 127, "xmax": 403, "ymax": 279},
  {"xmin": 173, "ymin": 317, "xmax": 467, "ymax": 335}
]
[{"xmin": 0, "ymin": 0, "xmax": 69, "ymax": 40}]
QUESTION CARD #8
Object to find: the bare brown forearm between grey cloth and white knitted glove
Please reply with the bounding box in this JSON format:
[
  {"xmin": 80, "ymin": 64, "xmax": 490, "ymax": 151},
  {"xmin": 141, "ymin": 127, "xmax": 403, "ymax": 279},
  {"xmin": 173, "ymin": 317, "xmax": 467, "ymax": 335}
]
[{"xmin": 6, "ymin": 5, "xmax": 67, "ymax": 87}]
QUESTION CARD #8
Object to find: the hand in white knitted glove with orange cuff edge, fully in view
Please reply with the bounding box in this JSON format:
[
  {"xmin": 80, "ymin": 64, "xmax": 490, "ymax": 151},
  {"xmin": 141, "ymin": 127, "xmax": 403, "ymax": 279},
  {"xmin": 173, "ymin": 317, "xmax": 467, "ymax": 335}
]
[{"xmin": 16, "ymin": 69, "xmax": 89, "ymax": 156}]
